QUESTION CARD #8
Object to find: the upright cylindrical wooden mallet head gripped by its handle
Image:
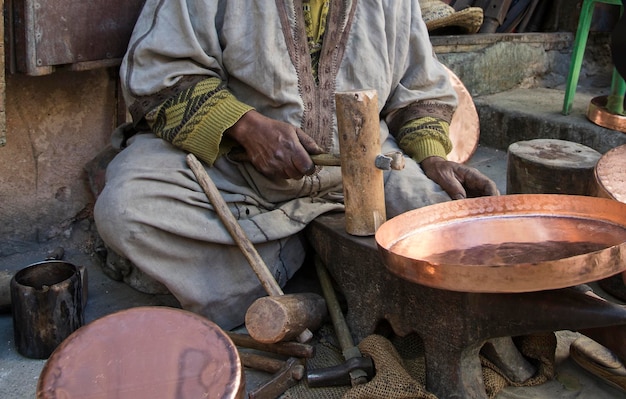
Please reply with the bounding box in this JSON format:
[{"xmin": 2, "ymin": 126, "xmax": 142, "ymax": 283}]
[{"xmin": 335, "ymin": 90, "xmax": 387, "ymax": 236}]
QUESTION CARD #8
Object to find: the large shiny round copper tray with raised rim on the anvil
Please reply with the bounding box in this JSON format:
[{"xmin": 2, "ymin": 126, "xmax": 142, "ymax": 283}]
[{"xmin": 375, "ymin": 194, "xmax": 626, "ymax": 293}]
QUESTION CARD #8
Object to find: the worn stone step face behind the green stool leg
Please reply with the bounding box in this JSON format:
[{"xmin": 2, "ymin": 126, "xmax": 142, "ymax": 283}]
[{"xmin": 431, "ymin": 32, "xmax": 612, "ymax": 97}]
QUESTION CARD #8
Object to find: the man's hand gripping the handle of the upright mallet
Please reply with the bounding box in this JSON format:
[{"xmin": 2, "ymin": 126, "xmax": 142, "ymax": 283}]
[{"xmin": 226, "ymin": 111, "xmax": 323, "ymax": 179}]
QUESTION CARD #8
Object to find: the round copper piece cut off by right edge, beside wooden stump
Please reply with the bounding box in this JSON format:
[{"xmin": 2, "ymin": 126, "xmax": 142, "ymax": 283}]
[{"xmin": 595, "ymin": 144, "xmax": 626, "ymax": 203}]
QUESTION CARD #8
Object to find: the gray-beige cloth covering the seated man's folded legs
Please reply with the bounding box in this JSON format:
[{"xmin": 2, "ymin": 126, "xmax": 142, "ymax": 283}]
[{"xmin": 94, "ymin": 134, "xmax": 450, "ymax": 329}]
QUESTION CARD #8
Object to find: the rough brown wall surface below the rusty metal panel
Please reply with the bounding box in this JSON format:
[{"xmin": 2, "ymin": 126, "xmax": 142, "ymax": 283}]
[{"xmin": 0, "ymin": 69, "xmax": 117, "ymax": 257}]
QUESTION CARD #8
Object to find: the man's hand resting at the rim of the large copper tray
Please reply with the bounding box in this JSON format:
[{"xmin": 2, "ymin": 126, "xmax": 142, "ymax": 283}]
[{"xmin": 421, "ymin": 157, "xmax": 500, "ymax": 199}]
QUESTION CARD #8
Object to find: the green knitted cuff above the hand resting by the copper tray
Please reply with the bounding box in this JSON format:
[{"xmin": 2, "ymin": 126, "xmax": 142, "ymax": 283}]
[{"xmin": 396, "ymin": 116, "xmax": 452, "ymax": 163}]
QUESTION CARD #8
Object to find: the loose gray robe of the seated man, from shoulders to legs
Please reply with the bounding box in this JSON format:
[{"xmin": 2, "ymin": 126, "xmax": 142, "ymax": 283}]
[{"xmin": 95, "ymin": 0, "xmax": 456, "ymax": 329}]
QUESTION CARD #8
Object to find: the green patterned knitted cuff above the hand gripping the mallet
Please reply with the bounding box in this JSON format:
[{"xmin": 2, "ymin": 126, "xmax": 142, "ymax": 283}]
[{"xmin": 146, "ymin": 78, "xmax": 253, "ymax": 165}]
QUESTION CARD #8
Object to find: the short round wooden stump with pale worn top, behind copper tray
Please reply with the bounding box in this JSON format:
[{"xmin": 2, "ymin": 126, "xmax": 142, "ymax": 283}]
[{"xmin": 506, "ymin": 139, "xmax": 601, "ymax": 196}]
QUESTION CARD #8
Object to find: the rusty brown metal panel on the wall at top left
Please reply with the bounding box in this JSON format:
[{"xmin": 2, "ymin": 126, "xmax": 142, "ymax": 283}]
[{"xmin": 8, "ymin": 0, "xmax": 144, "ymax": 75}]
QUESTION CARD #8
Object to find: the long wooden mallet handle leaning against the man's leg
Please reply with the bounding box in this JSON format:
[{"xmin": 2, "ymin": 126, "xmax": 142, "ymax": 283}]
[{"xmin": 187, "ymin": 154, "xmax": 313, "ymax": 342}]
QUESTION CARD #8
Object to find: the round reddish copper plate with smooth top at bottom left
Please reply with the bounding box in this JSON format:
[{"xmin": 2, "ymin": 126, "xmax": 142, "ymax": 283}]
[{"xmin": 37, "ymin": 307, "xmax": 245, "ymax": 399}]
